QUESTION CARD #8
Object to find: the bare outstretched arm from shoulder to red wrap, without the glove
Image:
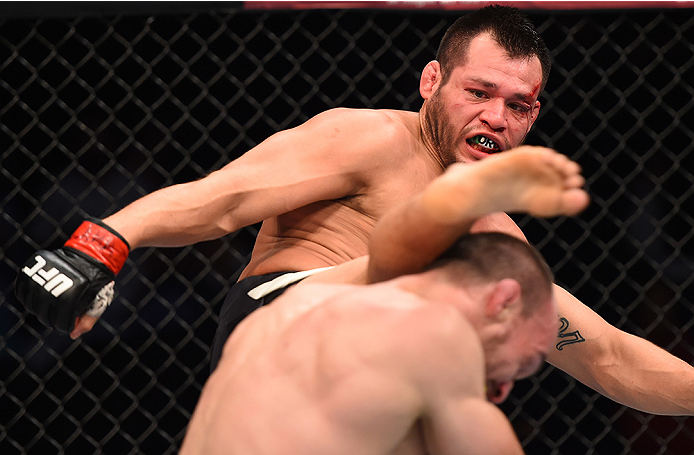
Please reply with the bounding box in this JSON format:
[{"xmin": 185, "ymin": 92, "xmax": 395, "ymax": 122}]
[{"xmin": 104, "ymin": 109, "xmax": 392, "ymax": 249}]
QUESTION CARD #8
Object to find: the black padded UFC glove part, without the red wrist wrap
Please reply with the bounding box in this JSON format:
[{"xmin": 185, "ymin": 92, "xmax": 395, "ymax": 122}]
[{"xmin": 15, "ymin": 248, "xmax": 115, "ymax": 333}]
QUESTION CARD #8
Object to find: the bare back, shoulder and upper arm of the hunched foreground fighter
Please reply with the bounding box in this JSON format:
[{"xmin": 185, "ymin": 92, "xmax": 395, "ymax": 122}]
[{"xmin": 180, "ymin": 277, "xmax": 522, "ymax": 455}]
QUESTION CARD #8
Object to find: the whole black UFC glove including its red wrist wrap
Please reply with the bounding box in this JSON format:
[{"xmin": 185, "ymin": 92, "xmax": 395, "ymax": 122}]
[{"xmin": 15, "ymin": 218, "xmax": 130, "ymax": 333}]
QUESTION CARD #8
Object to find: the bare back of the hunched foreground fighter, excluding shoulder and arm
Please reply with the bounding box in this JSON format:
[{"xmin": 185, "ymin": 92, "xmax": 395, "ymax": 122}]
[{"xmin": 181, "ymin": 285, "xmax": 454, "ymax": 455}]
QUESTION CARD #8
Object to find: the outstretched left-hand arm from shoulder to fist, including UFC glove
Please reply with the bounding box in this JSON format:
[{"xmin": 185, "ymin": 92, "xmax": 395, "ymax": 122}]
[{"xmin": 15, "ymin": 109, "xmax": 397, "ymax": 338}]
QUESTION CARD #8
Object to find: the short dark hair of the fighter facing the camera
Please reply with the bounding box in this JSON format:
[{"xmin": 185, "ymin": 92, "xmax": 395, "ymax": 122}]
[{"xmin": 436, "ymin": 5, "xmax": 552, "ymax": 91}]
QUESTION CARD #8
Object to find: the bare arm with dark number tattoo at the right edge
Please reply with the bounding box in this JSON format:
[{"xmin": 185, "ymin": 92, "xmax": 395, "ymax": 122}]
[{"xmin": 548, "ymin": 286, "xmax": 694, "ymax": 415}]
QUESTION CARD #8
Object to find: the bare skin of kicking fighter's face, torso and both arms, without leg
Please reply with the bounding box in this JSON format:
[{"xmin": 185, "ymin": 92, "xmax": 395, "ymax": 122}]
[{"xmin": 71, "ymin": 34, "xmax": 694, "ymax": 415}]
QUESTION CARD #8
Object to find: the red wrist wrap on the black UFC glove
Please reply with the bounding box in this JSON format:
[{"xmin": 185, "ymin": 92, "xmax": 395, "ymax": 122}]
[{"xmin": 65, "ymin": 221, "xmax": 130, "ymax": 275}]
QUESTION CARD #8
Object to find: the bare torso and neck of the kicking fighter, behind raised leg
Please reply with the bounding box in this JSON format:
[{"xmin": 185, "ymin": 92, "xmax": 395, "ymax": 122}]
[{"xmin": 241, "ymin": 111, "xmax": 520, "ymax": 279}]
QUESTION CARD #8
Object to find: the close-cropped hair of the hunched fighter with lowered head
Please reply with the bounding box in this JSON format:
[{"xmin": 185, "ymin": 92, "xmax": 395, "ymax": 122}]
[{"xmin": 429, "ymin": 232, "xmax": 554, "ymax": 317}]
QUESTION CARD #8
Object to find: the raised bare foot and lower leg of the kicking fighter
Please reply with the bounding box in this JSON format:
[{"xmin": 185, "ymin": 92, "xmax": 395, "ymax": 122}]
[{"xmin": 367, "ymin": 146, "xmax": 589, "ymax": 282}]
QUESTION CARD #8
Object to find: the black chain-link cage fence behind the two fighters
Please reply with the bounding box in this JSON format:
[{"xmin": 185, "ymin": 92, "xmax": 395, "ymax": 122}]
[{"xmin": 0, "ymin": 2, "xmax": 694, "ymax": 455}]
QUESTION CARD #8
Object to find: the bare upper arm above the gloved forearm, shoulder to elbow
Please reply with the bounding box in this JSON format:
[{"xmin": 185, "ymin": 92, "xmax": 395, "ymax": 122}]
[{"xmin": 215, "ymin": 111, "xmax": 383, "ymax": 226}]
